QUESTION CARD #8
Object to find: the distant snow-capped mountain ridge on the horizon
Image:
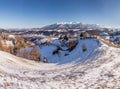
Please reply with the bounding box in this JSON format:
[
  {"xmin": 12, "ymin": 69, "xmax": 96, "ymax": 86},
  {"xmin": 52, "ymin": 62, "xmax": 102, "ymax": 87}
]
[{"xmin": 42, "ymin": 22, "xmax": 102, "ymax": 30}]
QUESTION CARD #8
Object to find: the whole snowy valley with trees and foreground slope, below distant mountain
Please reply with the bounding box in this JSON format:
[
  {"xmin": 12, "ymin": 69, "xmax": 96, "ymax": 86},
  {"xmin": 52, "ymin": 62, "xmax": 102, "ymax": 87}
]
[{"xmin": 0, "ymin": 22, "xmax": 120, "ymax": 89}]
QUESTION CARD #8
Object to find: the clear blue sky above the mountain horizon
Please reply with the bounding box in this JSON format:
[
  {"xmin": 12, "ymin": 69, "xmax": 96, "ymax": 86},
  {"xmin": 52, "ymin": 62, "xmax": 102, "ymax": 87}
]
[{"xmin": 0, "ymin": 0, "xmax": 120, "ymax": 28}]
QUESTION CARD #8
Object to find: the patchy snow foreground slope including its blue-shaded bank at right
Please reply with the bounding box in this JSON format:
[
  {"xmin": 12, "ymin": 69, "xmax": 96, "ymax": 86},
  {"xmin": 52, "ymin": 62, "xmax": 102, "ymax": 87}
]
[{"xmin": 0, "ymin": 40, "xmax": 120, "ymax": 89}]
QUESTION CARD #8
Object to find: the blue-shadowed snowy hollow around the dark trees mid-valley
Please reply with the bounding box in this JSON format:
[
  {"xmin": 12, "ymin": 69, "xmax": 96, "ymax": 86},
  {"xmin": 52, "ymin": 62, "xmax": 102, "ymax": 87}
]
[{"xmin": 38, "ymin": 39, "xmax": 100, "ymax": 64}]
